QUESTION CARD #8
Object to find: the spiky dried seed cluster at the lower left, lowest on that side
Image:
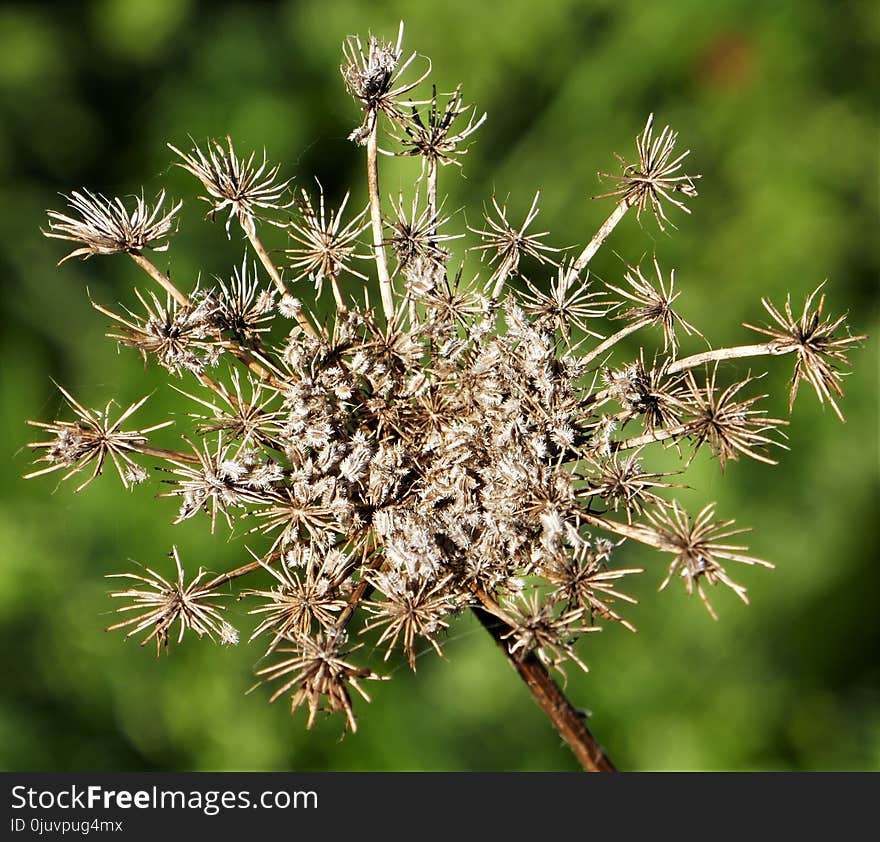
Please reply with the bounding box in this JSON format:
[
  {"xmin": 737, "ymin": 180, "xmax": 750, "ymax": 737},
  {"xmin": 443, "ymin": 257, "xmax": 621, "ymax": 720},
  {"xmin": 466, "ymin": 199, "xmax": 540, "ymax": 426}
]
[{"xmin": 107, "ymin": 547, "xmax": 238, "ymax": 655}]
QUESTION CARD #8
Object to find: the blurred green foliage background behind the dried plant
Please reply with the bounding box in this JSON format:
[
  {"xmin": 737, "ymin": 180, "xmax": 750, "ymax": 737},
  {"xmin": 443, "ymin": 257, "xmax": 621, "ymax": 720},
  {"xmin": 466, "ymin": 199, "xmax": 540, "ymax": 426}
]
[{"xmin": 0, "ymin": 0, "xmax": 880, "ymax": 770}]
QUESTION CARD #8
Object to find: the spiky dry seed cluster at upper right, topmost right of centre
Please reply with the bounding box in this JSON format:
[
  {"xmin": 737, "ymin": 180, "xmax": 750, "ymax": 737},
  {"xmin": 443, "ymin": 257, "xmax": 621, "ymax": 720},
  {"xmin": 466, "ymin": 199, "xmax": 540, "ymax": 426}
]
[{"xmin": 596, "ymin": 114, "xmax": 700, "ymax": 231}]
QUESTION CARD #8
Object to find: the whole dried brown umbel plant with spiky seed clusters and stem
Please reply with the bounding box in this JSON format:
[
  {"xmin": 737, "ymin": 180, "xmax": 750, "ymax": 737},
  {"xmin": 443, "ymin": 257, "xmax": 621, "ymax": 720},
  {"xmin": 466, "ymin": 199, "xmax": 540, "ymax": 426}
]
[{"xmin": 27, "ymin": 21, "xmax": 863, "ymax": 770}]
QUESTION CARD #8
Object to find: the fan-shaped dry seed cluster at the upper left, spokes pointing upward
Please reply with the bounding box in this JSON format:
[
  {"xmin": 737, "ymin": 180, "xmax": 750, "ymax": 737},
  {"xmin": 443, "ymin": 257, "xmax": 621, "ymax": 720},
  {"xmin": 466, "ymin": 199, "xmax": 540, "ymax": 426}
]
[{"xmin": 43, "ymin": 190, "xmax": 183, "ymax": 264}]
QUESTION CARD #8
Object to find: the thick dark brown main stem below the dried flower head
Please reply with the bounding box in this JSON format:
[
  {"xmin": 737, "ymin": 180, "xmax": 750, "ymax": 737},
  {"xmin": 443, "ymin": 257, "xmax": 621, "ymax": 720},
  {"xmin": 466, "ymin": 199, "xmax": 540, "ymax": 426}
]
[{"xmin": 473, "ymin": 606, "xmax": 617, "ymax": 772}]
